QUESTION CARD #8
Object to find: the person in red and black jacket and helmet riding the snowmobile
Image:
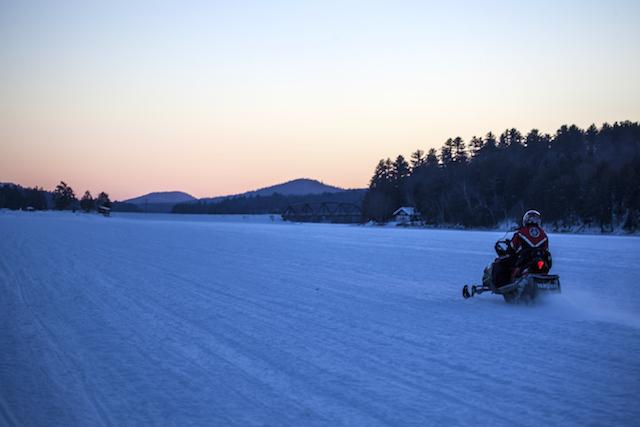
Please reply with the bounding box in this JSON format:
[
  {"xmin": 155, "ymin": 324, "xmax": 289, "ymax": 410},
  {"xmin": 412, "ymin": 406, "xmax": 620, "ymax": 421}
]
[{"xmin": 483, "ymin": 210, "xmax": 551, "ymax": 288}]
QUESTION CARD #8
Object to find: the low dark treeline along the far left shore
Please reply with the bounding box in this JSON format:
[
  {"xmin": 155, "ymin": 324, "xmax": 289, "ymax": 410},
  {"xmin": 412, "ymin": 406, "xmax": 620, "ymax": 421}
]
[{"xmin": 0, "ymin": 181, "xmax": 111, "ymax": 212}]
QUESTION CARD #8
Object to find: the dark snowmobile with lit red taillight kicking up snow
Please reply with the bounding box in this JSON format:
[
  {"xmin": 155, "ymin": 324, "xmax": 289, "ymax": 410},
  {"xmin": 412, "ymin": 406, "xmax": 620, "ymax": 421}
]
[{"xmin": 462, "ymin": 239, "xmax": 561, "ymax": 303}]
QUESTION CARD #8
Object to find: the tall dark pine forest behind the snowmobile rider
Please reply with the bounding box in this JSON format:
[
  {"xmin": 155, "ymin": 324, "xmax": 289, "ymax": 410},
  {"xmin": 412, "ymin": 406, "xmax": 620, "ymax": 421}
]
[{"xmin": 363, "ymin": 121, "xmax": 640, "ymax": 231}]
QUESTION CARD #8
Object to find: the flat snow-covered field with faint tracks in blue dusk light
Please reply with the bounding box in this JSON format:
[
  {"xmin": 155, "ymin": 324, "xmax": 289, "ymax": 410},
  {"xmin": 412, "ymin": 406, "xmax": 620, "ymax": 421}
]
[{"xmin": 0, "ymin": 211, "xmax": 640, "ymax": 426}]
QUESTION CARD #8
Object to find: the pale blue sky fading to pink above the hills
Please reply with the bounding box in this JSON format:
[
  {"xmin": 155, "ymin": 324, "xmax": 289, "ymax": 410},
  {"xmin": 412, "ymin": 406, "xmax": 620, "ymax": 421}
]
[{"xmin": 0, "ymin": 0, "xmax": 640, "ymax": 200}]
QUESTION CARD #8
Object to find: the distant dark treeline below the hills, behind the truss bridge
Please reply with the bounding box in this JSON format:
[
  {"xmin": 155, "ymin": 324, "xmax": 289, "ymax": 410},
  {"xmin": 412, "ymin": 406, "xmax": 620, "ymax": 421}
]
[{"xmin": 173, "ymin": 190, "xmax": 365, "ymax": 214}]
